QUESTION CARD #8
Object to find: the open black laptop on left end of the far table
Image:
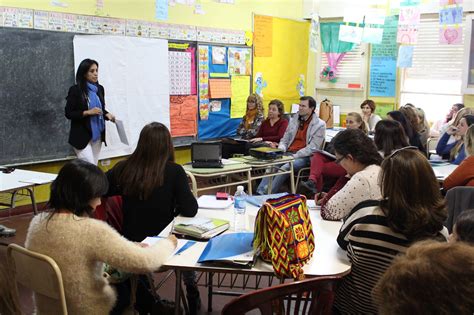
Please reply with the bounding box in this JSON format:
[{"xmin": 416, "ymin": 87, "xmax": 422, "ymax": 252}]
[{"xmin": 191, "ymin": 142, "xmax": 224, "ymax": 168}]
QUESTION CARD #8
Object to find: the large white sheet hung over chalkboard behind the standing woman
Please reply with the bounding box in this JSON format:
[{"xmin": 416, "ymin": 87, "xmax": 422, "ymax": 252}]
[{"xmin": 73, "ymin": 35, "xmax": 170, "ymax": 159}]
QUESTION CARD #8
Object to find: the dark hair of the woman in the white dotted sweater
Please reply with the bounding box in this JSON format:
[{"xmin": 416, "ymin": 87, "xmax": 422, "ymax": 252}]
[{"xmin": 331, "ymin": 129, "xmax": 382, "ymax": 166}]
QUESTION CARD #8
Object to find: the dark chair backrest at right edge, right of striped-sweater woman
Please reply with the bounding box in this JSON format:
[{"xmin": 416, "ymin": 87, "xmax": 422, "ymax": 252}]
[{"xmin": 444, "ymin": 186, "xmax": 474, "ymax": 233}]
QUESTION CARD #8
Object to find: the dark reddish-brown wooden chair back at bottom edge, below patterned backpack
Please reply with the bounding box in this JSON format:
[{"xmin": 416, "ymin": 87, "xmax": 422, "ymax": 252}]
[{"xmin": 222, "ymin": 277, "xmax": 341, "ymax": 315}]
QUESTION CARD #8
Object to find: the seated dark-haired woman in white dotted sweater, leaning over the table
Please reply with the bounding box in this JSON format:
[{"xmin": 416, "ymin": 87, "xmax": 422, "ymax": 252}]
[{"xmin": 315, "ymin": 129, "xmax": 382, "ymax": 220}]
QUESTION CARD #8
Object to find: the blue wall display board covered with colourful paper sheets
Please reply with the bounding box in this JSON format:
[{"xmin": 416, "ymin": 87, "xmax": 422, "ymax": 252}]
[{"xmin": 198, "ymin": 45, "xmax": 252, "ymax": 140}]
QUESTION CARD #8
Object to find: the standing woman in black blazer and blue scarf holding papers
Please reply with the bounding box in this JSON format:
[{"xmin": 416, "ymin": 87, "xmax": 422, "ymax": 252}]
[{"xmin": 65, "ymin": 59, "xmax": 115, "ymax": 165}]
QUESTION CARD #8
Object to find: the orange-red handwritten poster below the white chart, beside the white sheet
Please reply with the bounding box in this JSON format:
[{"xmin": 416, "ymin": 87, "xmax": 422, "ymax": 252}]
[{"xmin": 170, "ymin": 95, "xmax": 198, "ymax": 137}]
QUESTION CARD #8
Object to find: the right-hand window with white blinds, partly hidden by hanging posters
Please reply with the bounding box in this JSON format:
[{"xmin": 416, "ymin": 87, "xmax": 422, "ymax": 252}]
[{"xmin": 400, "ymin": 16, "xmax": 464, "ymax": 122}]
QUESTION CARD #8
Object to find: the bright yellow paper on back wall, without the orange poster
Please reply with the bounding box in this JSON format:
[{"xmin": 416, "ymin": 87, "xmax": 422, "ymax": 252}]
[{"xmin": 253, "ymin": 16, "xmax": 314, "ymax": 112}]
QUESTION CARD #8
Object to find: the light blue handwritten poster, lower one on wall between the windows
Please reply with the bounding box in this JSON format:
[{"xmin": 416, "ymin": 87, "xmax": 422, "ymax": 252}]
[{"xmin": 370, "ymin": 57, "xmax": 397, "ymax": 97}]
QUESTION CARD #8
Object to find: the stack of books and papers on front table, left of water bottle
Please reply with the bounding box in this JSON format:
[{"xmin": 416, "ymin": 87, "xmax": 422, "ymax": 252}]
[{"xmin": 173, "ymin": 217, "xmax": 230, "ymax": 240}]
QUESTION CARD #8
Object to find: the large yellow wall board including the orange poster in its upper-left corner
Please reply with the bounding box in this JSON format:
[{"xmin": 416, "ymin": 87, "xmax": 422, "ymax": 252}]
[{"xmin": 253, "ymin": 15, "xmax": 313, "ymax": 112}]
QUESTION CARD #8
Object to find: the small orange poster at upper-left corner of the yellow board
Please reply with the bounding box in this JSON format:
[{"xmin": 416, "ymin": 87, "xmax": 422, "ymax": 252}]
[{"xmin": 253, "ymin": 15, "xmax": 273, "ymax": 57}]
